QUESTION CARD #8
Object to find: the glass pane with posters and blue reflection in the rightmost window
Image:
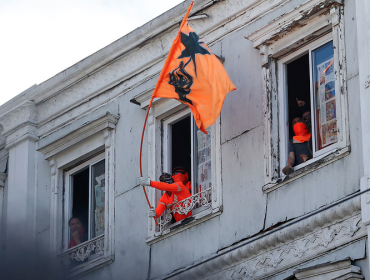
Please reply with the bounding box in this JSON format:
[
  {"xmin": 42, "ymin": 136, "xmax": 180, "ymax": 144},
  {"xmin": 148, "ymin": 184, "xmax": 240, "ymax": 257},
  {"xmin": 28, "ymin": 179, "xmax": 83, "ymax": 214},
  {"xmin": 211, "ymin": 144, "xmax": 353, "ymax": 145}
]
[{"xmin": 312, "ymin": 42, "xmax": 337, "ymax": 151}]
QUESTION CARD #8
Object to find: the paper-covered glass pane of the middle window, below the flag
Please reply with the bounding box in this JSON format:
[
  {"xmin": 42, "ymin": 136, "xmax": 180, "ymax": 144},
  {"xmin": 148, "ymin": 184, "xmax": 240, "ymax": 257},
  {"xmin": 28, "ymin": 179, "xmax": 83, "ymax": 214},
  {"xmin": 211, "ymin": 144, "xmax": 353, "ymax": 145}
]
[{"xmin": 192, "ymin": 121, "xmax": 212, "ymax": 197}]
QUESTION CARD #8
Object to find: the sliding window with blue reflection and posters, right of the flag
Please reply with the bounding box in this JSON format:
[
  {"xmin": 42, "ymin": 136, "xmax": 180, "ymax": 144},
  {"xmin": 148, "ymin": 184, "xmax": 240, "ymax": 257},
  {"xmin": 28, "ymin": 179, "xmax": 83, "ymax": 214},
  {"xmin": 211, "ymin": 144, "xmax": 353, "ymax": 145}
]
[{"xmin": 279, "ymin": 35, "xmax": 339, "ymax": 172}]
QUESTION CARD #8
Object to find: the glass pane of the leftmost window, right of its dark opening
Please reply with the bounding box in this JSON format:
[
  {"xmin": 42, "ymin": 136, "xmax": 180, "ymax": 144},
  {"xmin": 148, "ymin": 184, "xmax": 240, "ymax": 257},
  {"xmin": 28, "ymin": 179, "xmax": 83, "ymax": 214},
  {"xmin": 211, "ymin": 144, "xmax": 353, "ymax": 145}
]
[{"xmin": 91, "ymin": 160, "xmax": 105, "ymax": 238}]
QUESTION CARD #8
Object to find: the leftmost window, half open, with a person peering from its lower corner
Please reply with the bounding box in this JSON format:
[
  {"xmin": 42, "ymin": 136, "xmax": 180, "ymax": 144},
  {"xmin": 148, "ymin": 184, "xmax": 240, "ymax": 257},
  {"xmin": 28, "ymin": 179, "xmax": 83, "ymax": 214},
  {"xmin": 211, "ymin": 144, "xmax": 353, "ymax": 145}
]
[{"xmin": 65, "ymin": 155, "xmax": 105, "ymax": 245}]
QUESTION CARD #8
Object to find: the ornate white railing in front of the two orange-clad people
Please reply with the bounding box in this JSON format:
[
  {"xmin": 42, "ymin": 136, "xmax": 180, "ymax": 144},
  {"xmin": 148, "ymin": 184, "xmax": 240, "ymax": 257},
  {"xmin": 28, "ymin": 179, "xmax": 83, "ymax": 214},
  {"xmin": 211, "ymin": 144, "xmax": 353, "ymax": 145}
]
[{"xmin": 159, "ymin": 188, "xmax": 212, "ymax": 233}]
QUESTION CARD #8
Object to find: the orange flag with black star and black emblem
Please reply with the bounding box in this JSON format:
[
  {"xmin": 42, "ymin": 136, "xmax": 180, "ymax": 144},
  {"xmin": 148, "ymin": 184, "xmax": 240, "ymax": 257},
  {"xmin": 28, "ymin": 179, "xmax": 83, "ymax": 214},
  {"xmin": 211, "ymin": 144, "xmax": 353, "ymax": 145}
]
[{"xmin": 152, "ymin": 1, "xmax": 236, "ymax": 134}]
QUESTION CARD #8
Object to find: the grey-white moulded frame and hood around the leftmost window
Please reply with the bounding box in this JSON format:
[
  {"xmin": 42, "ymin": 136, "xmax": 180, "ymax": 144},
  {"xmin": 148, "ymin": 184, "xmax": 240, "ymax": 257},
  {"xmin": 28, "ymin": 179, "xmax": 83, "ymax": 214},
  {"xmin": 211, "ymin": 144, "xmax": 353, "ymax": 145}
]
[{"xmin": 38, "ymin": 110, "xmax": 119, "ymax": 277}]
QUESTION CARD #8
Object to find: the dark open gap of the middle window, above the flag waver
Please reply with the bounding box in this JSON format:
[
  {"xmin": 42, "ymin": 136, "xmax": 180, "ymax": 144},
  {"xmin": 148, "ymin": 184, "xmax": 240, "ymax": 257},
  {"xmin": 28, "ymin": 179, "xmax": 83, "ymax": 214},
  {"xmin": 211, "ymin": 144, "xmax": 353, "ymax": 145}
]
[{"xmin": 172, "ymin": 116, "xmax": 191, "ymax": 180}]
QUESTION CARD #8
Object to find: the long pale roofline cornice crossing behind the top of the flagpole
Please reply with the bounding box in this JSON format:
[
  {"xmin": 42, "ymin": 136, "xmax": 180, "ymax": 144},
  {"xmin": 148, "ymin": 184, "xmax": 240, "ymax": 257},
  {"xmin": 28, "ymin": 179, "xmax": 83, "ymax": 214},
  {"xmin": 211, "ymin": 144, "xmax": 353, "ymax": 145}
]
[{"xmin": 5, "ymin": 0, "xmax": 287, "ymax": 133}]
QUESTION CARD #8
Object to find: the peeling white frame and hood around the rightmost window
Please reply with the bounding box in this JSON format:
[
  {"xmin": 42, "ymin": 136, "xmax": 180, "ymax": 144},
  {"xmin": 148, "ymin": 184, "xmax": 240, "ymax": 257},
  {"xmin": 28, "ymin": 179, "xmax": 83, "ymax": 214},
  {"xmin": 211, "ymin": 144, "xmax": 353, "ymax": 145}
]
[{"xmin": 246, "ymin": 0, "xmax": 350, "ymax": 193}]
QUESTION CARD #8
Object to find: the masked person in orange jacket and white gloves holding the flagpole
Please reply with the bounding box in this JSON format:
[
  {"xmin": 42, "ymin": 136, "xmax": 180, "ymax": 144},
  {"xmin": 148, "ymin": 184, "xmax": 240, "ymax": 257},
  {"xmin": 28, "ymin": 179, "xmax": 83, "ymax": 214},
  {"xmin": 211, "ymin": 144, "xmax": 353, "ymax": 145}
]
[{"xmin": 139, "ymin": 173, "xmax": 192, "ymax": 222}]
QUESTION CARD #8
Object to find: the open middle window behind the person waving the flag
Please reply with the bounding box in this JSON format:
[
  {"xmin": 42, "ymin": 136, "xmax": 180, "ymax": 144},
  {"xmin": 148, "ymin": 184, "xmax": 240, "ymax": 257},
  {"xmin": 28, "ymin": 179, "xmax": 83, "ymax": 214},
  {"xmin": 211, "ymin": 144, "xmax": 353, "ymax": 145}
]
[{"xmin": 157, "ymin": 109, "xmax": 212, "ymax": 233}]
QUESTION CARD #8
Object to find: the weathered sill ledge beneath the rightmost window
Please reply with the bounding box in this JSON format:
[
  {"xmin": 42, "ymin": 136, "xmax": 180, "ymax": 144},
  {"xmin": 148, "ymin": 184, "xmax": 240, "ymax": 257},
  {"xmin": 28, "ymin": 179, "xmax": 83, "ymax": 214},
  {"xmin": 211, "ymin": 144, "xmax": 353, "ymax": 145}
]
[{"xmin": 262, "ymin": 146, "xmax": 351, "ymax": 193}]
